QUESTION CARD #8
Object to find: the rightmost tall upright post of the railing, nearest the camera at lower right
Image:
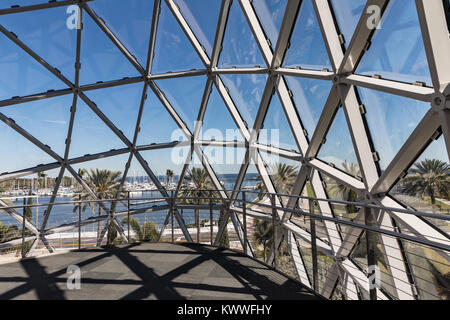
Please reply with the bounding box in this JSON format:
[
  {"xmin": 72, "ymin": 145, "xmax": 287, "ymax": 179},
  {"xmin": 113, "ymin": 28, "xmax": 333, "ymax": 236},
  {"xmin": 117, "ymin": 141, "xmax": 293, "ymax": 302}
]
[{"xmin": 364, "ymin": 207, "xmax": 378, "ymax": 300}]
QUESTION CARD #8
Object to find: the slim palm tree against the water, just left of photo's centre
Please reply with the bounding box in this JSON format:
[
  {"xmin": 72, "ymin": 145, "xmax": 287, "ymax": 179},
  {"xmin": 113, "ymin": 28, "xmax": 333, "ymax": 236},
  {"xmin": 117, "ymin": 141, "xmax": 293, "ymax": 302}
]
[{"xmin": 180, "ymin": 168, "xmax": 222, "ymax": 243}]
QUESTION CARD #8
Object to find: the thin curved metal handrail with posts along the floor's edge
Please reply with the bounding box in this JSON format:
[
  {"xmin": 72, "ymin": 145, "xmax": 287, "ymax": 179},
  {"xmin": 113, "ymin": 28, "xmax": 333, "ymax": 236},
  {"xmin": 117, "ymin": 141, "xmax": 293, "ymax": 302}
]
[{"xmin": 0, "ymin": 189, "xmax": 450, "ymax": 298}]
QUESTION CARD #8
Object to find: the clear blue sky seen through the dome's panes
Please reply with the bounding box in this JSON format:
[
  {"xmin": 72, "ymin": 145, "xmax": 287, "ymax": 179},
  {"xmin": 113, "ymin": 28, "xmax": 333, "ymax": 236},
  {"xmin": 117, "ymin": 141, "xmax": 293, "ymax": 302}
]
[{"xmin": 0, "ymin": 0, "xmax": 448, "ymax": 180}]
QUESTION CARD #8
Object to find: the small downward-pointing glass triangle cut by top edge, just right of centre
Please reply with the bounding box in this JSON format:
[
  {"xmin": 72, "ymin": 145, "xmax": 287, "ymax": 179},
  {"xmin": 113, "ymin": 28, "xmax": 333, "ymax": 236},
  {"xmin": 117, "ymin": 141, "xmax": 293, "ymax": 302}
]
[{"xmin": 252, "ymin": 0, "xmax": 287, "ymax": 50}]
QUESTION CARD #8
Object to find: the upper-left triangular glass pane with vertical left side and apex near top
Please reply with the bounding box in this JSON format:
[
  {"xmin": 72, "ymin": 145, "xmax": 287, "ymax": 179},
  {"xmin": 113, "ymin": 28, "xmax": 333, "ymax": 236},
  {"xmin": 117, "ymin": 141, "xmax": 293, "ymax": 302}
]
[{"xmin": 80, "ymin": 7, "xmax": 139, "ymax": 84}]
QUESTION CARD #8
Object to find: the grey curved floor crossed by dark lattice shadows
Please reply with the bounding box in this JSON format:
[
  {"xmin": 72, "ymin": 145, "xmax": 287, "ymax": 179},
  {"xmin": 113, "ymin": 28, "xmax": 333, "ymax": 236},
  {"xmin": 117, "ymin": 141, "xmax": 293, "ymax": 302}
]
[{"xmin": 0, "ymin": 243, "xmax": 318, "ymax": 300}]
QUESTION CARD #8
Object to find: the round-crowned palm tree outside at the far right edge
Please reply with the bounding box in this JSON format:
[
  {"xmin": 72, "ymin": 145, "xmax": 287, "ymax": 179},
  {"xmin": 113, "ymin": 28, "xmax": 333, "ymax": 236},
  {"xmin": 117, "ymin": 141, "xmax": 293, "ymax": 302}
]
[{"xmin": 401, "ymin": 159, "xmax": 450, "ymax": 206}]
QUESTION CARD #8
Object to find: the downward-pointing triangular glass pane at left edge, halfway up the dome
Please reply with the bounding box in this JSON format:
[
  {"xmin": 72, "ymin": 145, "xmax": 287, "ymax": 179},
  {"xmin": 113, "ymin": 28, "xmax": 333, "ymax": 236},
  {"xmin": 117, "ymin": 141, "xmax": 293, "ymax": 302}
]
[{"xmin": 2, "ymin": 95, "xmax": 73, "ymax": 157}]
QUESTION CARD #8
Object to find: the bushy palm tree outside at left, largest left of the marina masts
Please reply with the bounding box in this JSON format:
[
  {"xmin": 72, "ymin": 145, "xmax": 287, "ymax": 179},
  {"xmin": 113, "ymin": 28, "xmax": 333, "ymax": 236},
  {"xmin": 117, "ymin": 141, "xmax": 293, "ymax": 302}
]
[{"xmin": 72, "ymin": 169, "xmax": 122, "ymax": 243}]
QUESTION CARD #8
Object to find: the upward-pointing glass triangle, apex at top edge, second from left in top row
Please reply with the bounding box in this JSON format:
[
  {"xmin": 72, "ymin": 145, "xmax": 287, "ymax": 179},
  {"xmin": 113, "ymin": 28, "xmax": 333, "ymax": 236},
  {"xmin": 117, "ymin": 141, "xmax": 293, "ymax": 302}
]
[{"xmin": 152, "ymin": 1, "xmax": 204, "ymax": 74}]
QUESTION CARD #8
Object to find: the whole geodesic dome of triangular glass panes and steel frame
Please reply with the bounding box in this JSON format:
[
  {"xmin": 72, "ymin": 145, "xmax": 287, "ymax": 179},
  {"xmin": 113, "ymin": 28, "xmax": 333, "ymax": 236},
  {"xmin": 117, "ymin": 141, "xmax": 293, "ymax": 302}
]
[{"xmin": 0, "ymin": 0, "xmax": 450, "ymax": 299}]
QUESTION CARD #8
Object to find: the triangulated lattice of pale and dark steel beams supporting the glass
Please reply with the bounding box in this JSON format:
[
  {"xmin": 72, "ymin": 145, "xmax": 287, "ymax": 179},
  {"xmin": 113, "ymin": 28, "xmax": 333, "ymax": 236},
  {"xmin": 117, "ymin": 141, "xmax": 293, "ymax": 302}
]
[{"xmin": 0, "ymin": 0, "xmax": 450, "ymax": 299}]
